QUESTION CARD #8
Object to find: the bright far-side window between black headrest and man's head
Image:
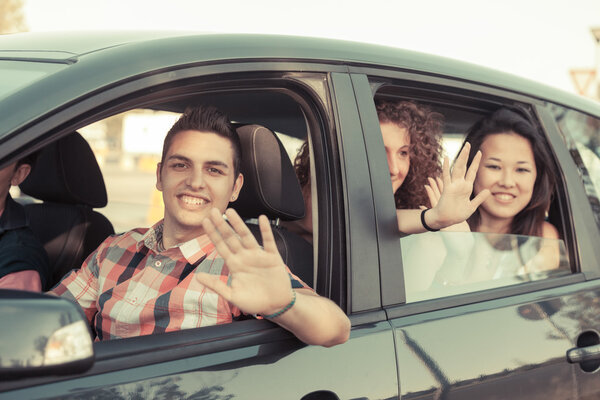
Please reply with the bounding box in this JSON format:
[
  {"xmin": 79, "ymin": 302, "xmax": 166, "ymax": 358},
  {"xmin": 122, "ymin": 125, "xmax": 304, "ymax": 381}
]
[{"xmin": 79, "ymin": 109, "xmax": 180, "ymax": 233}]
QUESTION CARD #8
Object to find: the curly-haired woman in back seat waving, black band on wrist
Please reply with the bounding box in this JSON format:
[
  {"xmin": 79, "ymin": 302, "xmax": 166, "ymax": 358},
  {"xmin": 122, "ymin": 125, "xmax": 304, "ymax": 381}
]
[{"xmin": 283, "ymin": 100, "xmax": 489, "ymax": 241}]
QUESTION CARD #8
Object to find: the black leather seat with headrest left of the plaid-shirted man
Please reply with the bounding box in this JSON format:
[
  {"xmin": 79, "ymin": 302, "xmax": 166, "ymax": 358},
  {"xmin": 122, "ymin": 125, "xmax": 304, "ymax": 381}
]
[{"xmin": 20, "ymin": 132, "xmax": 114, "ymax": 284}]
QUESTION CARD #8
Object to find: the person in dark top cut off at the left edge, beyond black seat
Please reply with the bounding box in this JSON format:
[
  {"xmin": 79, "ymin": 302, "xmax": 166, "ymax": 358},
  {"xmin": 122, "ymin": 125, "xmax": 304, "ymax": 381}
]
[{"xmin": 0, "ymin": 153, "xmax": 50, "ymax": 292}]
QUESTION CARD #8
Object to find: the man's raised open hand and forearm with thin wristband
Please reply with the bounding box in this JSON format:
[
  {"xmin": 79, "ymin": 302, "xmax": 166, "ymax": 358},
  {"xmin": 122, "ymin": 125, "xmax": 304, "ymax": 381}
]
[{"xmin": 197, "ymin": 209, "xmax": 350, "ymax": 346}]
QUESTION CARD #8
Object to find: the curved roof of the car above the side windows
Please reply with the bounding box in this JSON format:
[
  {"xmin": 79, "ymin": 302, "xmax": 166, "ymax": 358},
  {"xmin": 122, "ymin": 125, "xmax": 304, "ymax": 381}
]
[{"xmin": 0, "ymin": 31, "xmax": 599, "ymax": 136}]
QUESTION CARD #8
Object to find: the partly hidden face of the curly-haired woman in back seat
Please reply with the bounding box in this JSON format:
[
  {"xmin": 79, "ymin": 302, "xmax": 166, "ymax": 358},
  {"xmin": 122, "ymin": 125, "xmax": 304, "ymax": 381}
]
[{"xmin": 380, "ymin": 122, "xmax": 410, "ymax": 193}]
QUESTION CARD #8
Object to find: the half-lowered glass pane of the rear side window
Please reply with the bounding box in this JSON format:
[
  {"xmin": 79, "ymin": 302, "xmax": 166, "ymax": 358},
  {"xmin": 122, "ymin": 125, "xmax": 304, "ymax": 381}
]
[{"xmin": 400, "ymin": 232, "xmax": 571, "ymax": 302}]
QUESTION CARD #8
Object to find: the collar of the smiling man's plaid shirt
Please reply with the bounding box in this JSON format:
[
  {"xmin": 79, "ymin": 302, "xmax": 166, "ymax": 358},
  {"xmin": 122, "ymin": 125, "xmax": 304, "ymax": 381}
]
[{"xmin": 136, "ymin": 220, "xmax": 216, "ymax": 264}]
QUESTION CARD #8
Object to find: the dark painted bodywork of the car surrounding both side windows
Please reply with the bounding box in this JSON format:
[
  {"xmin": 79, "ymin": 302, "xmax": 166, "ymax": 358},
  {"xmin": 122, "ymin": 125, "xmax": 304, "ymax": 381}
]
[{"xmin": 0, "ymin": 32, "xmax": 600, "ymax": 399}]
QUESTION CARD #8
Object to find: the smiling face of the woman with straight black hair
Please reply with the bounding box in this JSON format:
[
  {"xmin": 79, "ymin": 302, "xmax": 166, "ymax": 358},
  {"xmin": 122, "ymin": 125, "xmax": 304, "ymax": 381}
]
[{"xmin": 474, "ymin": 132, "xmax": 537, "ymax": 233}]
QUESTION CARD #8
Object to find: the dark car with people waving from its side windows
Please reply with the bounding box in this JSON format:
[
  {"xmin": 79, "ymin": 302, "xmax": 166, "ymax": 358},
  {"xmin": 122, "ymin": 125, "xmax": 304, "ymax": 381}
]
[{"xmin": 0, "ymin": 32, "xmax": 600, "ymax": 400}]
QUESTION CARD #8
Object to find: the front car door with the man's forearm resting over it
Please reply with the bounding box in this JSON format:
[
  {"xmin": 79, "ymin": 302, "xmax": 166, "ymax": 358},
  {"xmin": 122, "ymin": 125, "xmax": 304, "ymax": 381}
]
[{"xmin": 0, "ymin": 49, "xmax": 398, "ymax": 399}]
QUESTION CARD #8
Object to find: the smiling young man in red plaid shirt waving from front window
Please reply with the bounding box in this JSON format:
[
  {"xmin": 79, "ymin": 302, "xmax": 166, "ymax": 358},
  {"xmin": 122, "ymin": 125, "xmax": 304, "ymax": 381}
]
[{"xmin": 52, "ymin": 107, "xmax": 350, "ymax": 346}]
